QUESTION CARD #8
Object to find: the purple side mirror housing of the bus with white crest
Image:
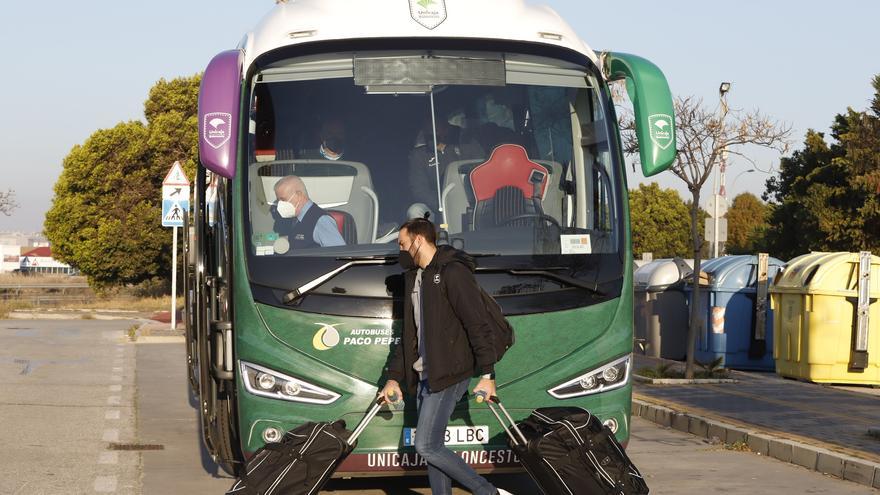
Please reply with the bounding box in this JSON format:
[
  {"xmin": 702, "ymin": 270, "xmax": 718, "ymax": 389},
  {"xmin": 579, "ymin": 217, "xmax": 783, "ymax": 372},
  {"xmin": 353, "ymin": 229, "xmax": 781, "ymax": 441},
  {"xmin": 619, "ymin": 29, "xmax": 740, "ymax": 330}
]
[{"xmin": 199, "ymin": 50, "xmax": 243, "ymax": 179}]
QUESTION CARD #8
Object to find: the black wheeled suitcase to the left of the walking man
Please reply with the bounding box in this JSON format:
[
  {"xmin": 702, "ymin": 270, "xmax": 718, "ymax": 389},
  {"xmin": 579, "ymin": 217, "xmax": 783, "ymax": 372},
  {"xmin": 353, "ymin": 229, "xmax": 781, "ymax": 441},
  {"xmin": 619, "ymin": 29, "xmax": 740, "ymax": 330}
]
[{"xmin": 226, "ymin": 398, "xmax": 385, "ymax": 495}]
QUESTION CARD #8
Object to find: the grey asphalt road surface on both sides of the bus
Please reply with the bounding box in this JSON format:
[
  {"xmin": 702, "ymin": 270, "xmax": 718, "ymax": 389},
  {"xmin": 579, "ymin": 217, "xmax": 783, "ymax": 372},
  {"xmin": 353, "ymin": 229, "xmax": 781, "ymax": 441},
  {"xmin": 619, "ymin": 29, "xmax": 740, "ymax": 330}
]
[{"xmin": 0, "ymin": 320, "xmax": 877, "ymax": 495}]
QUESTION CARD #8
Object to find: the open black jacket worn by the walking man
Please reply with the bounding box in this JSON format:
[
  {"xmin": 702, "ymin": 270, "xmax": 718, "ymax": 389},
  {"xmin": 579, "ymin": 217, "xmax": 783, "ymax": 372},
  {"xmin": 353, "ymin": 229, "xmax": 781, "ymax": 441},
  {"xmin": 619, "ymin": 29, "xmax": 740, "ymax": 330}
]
[{"xmin": 387, "ymin": 246, "xmax": 496, "ymax": 395}]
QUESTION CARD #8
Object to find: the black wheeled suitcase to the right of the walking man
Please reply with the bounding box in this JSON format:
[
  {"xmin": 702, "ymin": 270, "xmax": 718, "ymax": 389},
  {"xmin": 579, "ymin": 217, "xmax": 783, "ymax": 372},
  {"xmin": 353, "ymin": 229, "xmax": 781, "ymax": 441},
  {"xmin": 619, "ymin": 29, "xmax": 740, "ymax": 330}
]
[{"xmin": 488, "ymin": 397, "xmax": 648, "ymax": 495}]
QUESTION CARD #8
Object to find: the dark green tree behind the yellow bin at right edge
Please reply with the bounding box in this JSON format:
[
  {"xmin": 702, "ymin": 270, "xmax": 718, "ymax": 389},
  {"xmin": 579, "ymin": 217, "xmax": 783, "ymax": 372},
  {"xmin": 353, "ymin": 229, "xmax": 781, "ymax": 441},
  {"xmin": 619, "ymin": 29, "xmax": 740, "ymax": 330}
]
[{"xmin": 764, "ymin": 76, "xmax": 880, "ymax": 258}]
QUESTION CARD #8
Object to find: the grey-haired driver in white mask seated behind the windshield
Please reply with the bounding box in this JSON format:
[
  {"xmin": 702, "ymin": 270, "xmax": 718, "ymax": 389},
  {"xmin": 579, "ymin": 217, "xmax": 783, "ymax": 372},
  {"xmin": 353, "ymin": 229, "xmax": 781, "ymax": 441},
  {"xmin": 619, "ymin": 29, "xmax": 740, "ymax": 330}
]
[{"xmin": 270, "ymin": 175, "xmax": 345, "ymax": 254}]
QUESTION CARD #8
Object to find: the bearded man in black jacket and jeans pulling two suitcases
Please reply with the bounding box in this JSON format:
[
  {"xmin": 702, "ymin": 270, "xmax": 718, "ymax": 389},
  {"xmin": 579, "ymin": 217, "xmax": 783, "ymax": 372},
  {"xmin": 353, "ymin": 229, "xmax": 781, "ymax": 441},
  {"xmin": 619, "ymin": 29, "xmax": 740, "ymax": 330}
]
[{"xmin": 381, "ymin": 218, "xmax": 507, "ymax": 495}]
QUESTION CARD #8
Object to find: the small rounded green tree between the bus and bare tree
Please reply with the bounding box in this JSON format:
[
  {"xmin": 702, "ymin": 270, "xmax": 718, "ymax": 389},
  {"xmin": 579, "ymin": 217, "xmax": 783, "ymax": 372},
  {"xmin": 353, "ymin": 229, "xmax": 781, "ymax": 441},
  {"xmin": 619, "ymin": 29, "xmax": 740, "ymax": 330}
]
[{"xmin": 629, "ymin": 182, "xmax": 691, "ymax": 258}]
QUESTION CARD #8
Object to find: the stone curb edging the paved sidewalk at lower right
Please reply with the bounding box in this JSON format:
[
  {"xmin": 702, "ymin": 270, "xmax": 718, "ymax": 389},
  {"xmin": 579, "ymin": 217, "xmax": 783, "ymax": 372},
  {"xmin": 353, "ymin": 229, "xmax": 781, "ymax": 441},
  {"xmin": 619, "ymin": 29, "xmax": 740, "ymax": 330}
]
[{"xmin": 632, "ymin": 398, "xmax": 880, "ymax": 488}]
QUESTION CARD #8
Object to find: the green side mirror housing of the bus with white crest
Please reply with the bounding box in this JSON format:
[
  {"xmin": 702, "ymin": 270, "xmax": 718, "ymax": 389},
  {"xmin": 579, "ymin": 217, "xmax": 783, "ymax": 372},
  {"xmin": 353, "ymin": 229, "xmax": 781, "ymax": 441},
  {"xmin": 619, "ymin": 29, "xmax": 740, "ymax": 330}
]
[{"xmin": 602, "ymin": 52, "xmax": 676, "ymax": 177}]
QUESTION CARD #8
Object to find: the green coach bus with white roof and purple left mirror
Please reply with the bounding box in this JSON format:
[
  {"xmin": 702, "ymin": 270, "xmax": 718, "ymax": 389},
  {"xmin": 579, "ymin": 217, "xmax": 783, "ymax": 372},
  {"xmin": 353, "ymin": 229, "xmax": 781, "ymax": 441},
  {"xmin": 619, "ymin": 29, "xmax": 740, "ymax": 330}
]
[{"xmin": 184, "ymin": 0, "xmax": 676, "ymax": 477}]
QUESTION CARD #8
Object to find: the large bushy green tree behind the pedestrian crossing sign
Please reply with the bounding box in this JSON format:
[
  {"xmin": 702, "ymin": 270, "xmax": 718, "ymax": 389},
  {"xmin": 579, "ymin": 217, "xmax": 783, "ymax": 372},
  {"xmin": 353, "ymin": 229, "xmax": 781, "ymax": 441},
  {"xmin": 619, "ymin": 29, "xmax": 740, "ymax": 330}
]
[{"xmin": 45, "ymin": 75, "xmax": 201, "ymax": 288}]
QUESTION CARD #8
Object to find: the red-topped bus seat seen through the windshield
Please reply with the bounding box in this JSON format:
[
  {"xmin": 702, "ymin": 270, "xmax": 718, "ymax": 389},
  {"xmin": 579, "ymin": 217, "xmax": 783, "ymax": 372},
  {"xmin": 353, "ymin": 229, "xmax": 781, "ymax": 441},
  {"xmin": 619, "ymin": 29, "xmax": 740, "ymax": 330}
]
[{"xmin": 470, "ymin": 144, "xmax": 550, "ymax": 230}]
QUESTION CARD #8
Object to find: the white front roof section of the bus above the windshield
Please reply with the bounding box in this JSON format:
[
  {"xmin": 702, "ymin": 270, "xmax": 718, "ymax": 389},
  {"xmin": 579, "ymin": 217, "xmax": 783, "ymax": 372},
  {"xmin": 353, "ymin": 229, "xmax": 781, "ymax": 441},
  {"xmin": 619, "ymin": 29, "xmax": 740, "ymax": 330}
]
[{"xmin": 241, "ymin": 0, "xmax": 597, "ymax": 68}]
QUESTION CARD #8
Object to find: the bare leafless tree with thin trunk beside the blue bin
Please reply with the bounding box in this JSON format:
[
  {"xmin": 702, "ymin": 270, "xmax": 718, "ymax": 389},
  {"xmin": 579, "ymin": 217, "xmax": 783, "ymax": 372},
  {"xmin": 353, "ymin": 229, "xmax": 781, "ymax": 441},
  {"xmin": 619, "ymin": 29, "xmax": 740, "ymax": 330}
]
[{"xmin": 621, "ymin": 96, "xmax": 791, "ymax": 378}]
